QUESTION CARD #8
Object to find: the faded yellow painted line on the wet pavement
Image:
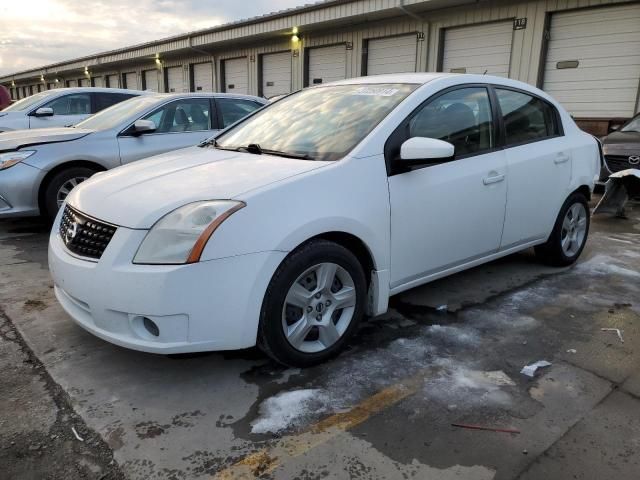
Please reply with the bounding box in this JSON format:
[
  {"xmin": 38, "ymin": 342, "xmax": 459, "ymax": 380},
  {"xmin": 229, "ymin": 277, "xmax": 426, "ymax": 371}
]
[{"xmin": 213, "ymin": 371, "xmax": 425, "ymax": 480}]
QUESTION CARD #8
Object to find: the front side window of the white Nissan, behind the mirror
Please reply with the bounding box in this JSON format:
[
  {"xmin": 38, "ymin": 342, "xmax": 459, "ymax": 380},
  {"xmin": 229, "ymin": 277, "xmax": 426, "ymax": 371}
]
[{"xmin": 408, "ymin": 87, "xmax": 494, "ymax": 157}]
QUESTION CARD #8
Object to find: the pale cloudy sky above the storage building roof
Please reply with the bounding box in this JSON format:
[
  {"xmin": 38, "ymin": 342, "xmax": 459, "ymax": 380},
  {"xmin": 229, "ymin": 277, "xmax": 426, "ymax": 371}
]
[{"xmin": 0, "ymin": 0, "xmax": 315, "ymax": 75}]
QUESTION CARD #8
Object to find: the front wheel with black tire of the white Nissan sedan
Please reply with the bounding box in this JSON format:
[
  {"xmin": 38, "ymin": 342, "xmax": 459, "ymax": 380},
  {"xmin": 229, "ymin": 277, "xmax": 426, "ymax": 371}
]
[{"xmin": 258, "ymin": 239, "xmax": 367, "ymax": 367}]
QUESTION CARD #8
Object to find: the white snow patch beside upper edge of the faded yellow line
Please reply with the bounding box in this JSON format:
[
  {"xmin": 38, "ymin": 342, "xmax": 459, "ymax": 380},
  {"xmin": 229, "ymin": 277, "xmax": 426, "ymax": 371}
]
[{"xmin": 251, "ymin": 388, "xmax": 326, "ymax": 433}]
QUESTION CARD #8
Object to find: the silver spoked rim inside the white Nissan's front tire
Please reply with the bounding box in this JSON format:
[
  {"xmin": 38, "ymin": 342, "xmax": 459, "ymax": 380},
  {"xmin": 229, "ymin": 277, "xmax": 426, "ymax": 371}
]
[{"xmin": 282, "ymin": 263, "xmax": 357, "ymax": 353}]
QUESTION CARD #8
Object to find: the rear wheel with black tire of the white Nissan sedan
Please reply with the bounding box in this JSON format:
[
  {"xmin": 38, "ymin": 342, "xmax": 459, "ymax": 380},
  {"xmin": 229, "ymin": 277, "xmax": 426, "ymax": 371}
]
[{"xmin": 535, "ymin": 192, "xmax": 591, "ymax": 267}]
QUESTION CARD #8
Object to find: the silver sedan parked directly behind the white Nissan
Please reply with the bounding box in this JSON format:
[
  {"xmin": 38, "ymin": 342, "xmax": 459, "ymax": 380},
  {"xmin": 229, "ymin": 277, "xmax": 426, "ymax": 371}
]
[{"xmin": 0, "ymin": 93, "xmax": 267, "ymax": 218}]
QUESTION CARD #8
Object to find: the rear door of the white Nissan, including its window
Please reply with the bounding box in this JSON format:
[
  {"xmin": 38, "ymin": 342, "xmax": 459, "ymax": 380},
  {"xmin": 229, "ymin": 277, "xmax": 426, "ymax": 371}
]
[{"xmin": 495, "ymin": 87, "xmax": 572, "ymax": 250}]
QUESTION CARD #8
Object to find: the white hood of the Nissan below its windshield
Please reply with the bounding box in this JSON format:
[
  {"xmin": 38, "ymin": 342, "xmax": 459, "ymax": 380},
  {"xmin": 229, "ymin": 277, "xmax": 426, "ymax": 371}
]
[{"xmin": 68, "ymin": 147, "xmax": 328, "ymax": 229}]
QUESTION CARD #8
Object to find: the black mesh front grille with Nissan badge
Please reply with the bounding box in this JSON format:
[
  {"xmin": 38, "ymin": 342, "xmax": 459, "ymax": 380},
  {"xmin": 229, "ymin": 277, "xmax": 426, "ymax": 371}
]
[{"xmin": 60, "ymin": 205, "xmax": 117, "ymax": 259}]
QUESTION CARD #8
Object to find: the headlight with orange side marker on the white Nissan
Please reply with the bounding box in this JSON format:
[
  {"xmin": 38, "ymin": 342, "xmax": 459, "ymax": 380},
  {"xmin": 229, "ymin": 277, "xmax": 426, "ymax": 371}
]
[{"xmin": 133, "ymin": 200, "xmax": 245, "ymax": 265}]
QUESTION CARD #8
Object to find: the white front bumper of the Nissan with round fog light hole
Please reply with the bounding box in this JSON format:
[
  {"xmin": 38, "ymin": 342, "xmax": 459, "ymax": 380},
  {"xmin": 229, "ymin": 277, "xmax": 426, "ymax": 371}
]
[{"xmin": 49, "ymin": 212, "xmax": 286, "ymax": 354}]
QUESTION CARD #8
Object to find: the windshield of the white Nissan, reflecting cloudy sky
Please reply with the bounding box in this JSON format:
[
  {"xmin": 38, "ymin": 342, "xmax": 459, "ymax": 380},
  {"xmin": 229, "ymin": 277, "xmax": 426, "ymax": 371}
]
[{"xmin": 216, "ymin": 84, "xmax": 418, "ymax": 161}]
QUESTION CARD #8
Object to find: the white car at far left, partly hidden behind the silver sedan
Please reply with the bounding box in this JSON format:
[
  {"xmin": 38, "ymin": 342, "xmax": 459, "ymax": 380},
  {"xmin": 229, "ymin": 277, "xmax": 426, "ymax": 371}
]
[{"xmin": 0, "ymin": 87, "xmax": 144, "ymax": 132}]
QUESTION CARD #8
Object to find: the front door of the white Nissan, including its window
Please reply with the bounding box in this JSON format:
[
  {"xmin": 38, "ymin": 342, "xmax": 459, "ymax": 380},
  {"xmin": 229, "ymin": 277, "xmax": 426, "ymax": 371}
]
[{"xmin": 389, "ymin": 86, "xmax": 507, "ymax": 291}]
